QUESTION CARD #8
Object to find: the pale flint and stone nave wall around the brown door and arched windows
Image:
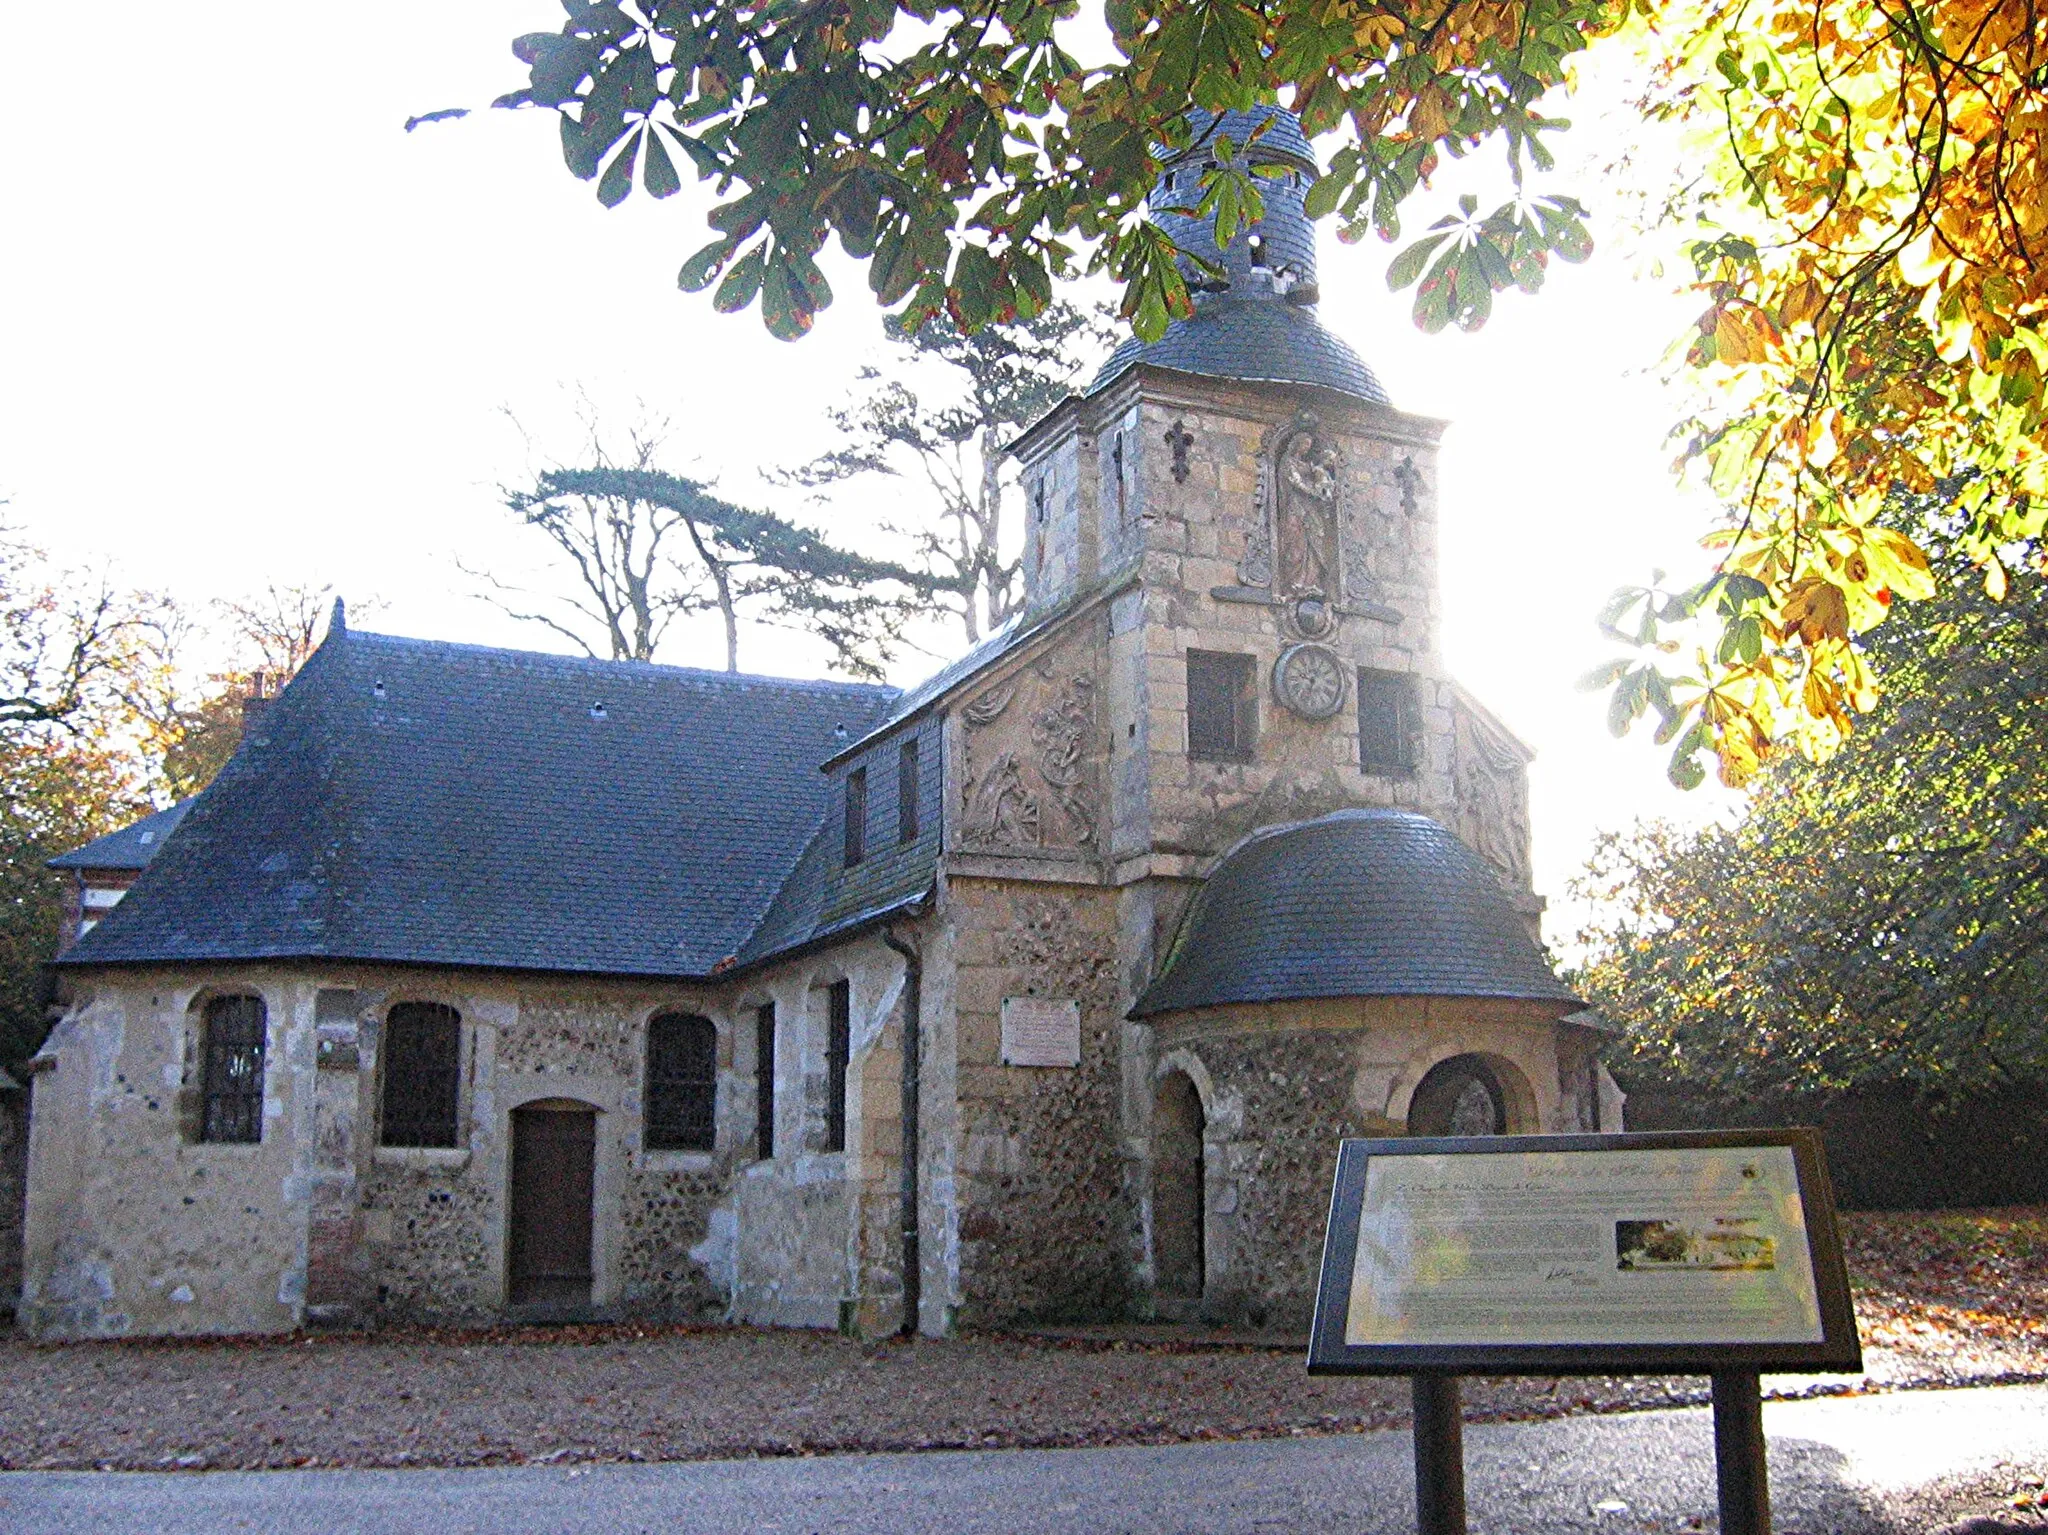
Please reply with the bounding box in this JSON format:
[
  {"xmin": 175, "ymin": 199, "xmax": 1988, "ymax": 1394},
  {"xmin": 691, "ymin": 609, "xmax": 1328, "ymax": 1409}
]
[{"xmin": 20, "ymin": 968, "xmax": 774, "ymax": 1336}]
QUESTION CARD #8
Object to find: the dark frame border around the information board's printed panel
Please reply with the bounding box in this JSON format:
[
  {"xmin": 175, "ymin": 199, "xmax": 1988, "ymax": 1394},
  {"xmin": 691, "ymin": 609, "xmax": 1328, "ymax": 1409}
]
[{"xmin": 1309, "ymin": 1128, "xmax": 1864, "ymax": 1375}]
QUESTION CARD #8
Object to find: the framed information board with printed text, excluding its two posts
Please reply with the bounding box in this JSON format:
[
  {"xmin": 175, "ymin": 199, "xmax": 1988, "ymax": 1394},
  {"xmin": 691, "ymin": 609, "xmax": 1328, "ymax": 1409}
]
[{"xmin": 1309, "ymin": 1130, "xmax": 1862, "ymax": 1375}]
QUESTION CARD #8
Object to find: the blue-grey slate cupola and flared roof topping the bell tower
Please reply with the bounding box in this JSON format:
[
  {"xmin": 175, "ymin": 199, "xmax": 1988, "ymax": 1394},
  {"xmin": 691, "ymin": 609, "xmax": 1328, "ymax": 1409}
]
[{"xmin": 1090, "ymin": 106, "xmax": 1391, "ymax": 405}]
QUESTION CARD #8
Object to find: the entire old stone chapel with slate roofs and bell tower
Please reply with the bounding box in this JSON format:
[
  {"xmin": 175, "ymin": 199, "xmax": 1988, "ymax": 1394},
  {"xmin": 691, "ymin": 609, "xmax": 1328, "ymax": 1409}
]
[{"xmin": 18, "ymin": 108, "xmax": 1620, "ymax": 1339}]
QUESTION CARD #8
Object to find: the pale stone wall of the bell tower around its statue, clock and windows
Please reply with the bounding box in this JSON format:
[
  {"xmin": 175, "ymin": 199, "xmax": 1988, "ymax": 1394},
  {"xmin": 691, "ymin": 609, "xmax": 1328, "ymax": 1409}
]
[{"xmin": 1020, "ymin": 368, "xmax": 1456, "ymax": 878}]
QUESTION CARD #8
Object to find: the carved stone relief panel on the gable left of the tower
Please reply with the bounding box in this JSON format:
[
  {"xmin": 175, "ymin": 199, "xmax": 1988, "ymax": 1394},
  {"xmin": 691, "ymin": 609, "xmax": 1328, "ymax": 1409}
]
[{"xmin": 961, "ymin": 653, "xmax": 1102, "ymax": 853}]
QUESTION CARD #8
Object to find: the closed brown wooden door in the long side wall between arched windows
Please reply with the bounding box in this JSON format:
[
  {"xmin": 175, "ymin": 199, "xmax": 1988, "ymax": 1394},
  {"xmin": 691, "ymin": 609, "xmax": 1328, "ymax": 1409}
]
[{"xmin": 510, "ymin": 1105, "xmax": 598, "ymax": 1306}]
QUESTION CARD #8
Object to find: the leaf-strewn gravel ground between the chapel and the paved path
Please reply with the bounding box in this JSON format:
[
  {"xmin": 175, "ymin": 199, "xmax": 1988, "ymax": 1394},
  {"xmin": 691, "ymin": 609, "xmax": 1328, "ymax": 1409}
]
[{"xmin": 0, "ymin": 1210, "xmax": 2048, "ymax": 1470}]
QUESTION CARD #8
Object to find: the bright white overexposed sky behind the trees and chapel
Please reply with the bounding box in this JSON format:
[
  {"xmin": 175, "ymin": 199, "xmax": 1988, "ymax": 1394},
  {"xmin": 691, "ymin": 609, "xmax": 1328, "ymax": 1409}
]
[{"xmin": 0, "ymin": 0, "xmax": 1744, "ymax": 939}]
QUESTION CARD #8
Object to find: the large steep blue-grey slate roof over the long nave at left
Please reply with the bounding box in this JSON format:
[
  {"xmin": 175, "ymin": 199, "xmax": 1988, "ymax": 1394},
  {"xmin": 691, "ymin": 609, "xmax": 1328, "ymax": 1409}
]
[{"xmin": 59, "ymin": 630, "xmax": 897, "ymax": 976}]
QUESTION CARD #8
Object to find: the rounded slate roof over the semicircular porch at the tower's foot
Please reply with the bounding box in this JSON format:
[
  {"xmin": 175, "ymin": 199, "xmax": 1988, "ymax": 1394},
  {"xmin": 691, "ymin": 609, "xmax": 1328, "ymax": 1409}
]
[{"xmin": 1130, "ymin": 810, "xmax": 1583, "ymax": 1017}]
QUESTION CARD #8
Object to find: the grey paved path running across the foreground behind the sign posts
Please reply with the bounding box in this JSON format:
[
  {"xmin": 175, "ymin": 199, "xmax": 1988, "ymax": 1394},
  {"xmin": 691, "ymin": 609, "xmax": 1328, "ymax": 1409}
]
[{"xmin": 0, "ymin": 1386, "xmax": 2048, "ymax": 1535}]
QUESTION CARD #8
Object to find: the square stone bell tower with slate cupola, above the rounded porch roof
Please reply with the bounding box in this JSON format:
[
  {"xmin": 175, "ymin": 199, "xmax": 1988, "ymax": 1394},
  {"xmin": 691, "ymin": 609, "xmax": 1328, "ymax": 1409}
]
[{"xmin": 1014, "ymin": 106, "xmax": 1540, "ymax": 968}]
